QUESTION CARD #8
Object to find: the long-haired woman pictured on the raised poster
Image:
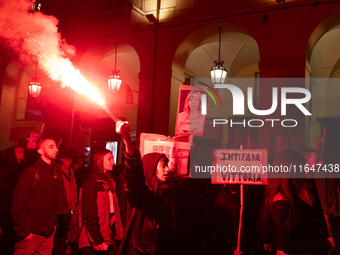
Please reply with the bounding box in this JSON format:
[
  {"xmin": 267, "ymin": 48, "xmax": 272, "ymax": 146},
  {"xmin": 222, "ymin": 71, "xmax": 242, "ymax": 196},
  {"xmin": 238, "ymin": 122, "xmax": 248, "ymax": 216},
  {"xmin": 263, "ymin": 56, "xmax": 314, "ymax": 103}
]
[{"xmin": 176, "ymin": 90, "xmax": 205, "ymax": 135}]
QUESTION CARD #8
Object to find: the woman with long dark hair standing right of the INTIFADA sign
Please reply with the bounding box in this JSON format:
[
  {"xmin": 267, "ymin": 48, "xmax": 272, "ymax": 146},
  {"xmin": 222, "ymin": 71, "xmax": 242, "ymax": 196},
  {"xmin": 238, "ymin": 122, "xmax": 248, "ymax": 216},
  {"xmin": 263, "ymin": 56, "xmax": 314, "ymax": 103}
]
[{"xmin": 261, "ymin": 150, "xmax": 335, "ymax": 255}]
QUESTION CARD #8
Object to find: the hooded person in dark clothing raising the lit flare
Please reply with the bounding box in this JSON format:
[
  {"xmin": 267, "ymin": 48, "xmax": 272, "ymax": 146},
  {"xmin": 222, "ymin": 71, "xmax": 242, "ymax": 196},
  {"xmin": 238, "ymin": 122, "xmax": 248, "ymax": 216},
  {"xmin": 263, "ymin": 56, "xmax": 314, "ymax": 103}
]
[{"xmin": 116, "ymin": 122, "xmax": 174, "ymax": 255}]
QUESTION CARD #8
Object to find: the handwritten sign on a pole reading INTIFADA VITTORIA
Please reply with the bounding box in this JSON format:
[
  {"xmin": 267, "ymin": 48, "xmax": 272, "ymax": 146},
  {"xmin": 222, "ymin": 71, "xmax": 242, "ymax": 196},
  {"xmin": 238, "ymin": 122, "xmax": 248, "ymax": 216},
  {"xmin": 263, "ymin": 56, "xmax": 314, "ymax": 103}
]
[{"xmin": 209, "ymin": 149, "xmax": 268, "ymax": 185}]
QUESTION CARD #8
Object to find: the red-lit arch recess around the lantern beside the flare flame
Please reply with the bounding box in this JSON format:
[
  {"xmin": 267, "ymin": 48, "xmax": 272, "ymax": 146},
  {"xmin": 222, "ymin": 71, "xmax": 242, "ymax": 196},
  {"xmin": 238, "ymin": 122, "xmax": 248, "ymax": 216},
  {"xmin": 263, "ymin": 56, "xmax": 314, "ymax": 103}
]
[{"xmin": 75, "ymin": 35, "xmax": 151, "ymax": 128}]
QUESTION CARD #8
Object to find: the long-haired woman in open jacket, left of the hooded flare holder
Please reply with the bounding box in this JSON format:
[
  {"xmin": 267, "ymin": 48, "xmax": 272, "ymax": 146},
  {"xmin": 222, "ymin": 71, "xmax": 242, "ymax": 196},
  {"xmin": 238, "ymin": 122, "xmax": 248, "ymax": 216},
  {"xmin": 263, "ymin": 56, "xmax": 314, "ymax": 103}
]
[{"xmin": 79, "ymin": 149, "xmax": 123, "ymax": 255}]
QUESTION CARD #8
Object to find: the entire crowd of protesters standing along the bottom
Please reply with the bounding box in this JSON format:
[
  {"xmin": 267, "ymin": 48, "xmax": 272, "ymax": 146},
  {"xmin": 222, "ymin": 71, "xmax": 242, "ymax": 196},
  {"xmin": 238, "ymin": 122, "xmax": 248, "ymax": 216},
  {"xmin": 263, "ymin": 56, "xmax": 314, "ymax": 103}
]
[{"xmin": 0, "ymin": 122, "xmax": 340, "ymax": 255}]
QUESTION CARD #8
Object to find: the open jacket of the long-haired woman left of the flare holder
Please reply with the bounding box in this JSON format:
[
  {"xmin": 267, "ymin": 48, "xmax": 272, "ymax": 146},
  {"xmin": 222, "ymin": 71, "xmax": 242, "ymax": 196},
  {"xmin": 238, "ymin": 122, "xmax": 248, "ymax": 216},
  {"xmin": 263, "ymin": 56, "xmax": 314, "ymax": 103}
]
[{"xmin": 79, "ymin": 173, "xmax": 123, "ymax": 248}]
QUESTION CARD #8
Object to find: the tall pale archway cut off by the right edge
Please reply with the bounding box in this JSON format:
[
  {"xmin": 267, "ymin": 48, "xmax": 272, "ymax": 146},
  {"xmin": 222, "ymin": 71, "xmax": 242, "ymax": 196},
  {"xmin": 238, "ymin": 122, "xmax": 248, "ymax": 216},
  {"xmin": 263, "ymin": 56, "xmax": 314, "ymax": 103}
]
[{"xmin": 306, "ymin": 8, "xmax": 340, "ymax": 151}]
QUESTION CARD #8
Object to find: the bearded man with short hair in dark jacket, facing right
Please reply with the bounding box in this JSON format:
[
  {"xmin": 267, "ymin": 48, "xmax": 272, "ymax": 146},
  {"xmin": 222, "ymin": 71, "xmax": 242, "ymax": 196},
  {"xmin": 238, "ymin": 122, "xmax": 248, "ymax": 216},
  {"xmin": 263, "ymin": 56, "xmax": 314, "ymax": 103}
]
[{"xmin": 11, "ymin": 137, "xmax": 69, "ymax": 255}]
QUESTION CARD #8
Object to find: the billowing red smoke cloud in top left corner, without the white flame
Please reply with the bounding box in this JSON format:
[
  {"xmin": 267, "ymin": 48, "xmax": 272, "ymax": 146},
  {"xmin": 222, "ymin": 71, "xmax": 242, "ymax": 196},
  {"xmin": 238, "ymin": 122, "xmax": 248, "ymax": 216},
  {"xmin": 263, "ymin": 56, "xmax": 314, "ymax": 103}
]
[{"xmin": 0, "ymin": 0, "xmax": 75, "ymax": 65}]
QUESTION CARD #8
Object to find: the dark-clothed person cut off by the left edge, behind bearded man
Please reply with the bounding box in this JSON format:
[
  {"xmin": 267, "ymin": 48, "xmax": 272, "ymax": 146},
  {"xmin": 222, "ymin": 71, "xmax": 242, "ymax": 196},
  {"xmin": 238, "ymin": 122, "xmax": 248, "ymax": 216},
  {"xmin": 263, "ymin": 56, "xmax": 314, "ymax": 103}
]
[{"xmin": 0, "ymin": 146, "xmax": 24, "ymax": 255}]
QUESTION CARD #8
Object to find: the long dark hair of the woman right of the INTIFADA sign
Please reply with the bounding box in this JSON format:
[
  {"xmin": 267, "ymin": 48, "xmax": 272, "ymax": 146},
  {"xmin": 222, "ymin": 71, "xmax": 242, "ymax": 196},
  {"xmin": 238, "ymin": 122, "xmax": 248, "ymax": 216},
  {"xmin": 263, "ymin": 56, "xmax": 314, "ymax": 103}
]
[{"xmin": 261, "ymin": 150, "xmax": 306, "ymax": 229}]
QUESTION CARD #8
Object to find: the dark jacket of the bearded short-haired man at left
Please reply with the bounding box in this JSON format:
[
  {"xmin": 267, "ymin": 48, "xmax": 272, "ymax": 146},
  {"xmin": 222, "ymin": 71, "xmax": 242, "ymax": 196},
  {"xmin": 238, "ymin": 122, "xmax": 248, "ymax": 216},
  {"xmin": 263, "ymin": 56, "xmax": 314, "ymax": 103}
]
[{"xmin": 11, "ymin": 158, "xmax": 69, "ymax": 239}]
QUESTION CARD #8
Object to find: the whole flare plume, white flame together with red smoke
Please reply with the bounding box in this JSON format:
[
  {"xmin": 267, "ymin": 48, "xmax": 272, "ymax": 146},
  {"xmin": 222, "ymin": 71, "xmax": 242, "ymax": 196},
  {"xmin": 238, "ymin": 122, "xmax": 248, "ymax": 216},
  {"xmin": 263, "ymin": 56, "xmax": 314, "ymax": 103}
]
[{"xmin": 0, "ymin": 0, "xmax": 105, "ymax": 105}]
